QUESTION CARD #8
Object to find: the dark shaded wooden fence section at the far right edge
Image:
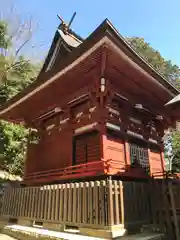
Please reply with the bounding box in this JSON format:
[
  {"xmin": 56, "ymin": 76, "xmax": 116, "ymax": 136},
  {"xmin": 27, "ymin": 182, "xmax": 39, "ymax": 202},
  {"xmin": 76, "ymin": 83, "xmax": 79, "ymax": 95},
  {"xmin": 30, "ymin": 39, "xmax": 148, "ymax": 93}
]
[{"xmin": 151, "ymin": 179, "xmax": 180, "ymax": 240}]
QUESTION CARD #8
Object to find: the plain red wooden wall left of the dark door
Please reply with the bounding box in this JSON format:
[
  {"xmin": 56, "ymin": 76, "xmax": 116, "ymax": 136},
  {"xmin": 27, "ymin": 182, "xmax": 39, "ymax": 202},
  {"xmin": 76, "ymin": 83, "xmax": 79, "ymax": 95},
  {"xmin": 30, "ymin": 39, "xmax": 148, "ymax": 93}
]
[{"xmin": 26, "ymin": 129, "xmax": 72, "ymax": 174}]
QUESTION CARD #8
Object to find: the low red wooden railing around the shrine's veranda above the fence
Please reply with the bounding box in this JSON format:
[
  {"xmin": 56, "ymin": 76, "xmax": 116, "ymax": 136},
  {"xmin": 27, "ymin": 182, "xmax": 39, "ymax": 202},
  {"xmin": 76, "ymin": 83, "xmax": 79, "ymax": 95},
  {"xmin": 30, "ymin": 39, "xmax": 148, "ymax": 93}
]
[{"xmin": 24, "ymin": 159, "xmax": 164, "ymax": 183}]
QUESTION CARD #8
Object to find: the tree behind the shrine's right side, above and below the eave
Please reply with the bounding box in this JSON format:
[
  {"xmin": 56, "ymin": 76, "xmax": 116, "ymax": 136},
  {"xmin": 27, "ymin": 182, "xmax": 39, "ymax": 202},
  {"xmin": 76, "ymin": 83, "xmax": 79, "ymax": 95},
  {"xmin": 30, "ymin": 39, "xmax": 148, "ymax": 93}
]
[{"xmin": 127, "ymin": 37, "xmax": 180, "ymax": 172}]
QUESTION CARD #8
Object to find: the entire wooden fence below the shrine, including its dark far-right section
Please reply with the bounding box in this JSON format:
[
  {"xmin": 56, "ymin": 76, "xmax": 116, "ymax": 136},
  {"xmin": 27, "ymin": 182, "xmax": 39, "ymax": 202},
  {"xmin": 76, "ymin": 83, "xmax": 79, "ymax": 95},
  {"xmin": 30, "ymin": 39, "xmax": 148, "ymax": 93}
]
[{"xmin": 1, "ymin": 180, "xmax": 180, "ymax": 240}]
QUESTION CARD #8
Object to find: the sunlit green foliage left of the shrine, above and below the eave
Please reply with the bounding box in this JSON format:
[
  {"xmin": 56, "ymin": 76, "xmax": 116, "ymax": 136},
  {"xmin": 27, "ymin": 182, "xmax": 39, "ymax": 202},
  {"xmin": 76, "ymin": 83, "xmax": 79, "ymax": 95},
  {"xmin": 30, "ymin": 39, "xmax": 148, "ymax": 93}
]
[{"xmin": 0, "ymin": 21, "xmax": 40, "ymax": 175}]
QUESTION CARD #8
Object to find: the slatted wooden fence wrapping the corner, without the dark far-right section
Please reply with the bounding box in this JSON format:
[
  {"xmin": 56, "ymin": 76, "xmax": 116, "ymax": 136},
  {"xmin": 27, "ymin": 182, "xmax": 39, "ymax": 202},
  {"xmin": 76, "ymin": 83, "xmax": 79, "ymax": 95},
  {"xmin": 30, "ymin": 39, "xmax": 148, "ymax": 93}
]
[{"xmin": 1, "ymin": 180, "xmax": 150, "ymax": 228}]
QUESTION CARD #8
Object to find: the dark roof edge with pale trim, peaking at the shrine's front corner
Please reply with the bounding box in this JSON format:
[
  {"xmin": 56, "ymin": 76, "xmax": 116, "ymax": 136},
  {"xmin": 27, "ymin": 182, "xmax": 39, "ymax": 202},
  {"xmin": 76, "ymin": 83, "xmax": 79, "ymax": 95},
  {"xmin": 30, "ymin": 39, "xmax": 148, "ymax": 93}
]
[{"xmin": 0, "ymin": 19, "xmax": 180, "ymax": 122}]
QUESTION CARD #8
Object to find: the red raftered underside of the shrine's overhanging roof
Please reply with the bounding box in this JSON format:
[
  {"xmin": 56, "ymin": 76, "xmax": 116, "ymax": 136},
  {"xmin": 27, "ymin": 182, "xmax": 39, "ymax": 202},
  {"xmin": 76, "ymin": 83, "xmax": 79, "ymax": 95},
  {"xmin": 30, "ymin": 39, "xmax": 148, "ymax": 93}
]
[{"xmin": 0, "ymin": 40, "xmax": 177, "ymax": 124}]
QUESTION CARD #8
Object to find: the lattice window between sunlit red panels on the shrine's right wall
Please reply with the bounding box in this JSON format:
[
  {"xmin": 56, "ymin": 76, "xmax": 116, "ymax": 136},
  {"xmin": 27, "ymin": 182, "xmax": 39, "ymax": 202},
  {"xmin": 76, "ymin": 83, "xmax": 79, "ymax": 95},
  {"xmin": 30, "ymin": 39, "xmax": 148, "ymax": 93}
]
[{"xmin": 129, "ymin": 143, "xmax": 150, "ymax": 172}]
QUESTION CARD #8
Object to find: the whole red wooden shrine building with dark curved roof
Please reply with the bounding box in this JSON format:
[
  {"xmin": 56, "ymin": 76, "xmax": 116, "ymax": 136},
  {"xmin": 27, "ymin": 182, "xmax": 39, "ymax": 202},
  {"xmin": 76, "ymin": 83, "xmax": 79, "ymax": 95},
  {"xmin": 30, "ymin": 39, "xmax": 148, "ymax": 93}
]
[{"xmin": 0, "ymin": 20, "xmax": 179, "ymax": 184}]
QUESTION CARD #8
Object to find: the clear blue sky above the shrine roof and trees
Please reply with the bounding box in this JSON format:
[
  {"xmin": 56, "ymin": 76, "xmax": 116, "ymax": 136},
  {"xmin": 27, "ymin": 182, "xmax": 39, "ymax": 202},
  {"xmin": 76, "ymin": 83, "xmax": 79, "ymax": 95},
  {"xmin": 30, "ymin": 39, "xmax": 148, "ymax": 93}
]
[{"xmin": 0, "ymin": 0, "xmax": 180, "ymax": 66}]
